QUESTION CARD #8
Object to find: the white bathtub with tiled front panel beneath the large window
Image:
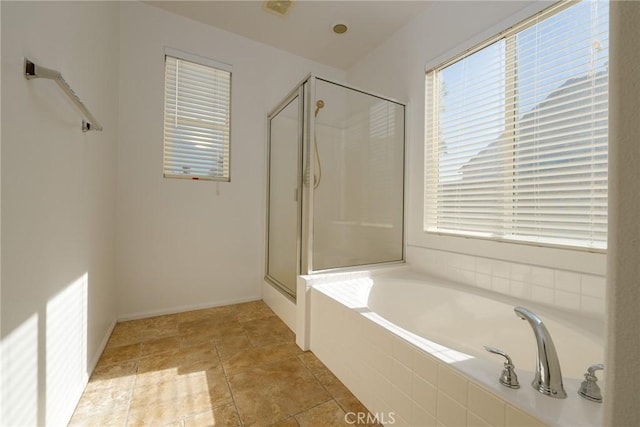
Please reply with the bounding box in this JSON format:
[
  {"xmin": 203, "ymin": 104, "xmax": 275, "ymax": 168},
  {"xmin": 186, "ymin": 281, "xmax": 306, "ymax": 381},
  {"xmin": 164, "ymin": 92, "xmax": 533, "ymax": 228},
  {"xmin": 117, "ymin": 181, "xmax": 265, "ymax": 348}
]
[{"xmin": 307, "ymin": 270, "xmax": 606, "ymax": 427}]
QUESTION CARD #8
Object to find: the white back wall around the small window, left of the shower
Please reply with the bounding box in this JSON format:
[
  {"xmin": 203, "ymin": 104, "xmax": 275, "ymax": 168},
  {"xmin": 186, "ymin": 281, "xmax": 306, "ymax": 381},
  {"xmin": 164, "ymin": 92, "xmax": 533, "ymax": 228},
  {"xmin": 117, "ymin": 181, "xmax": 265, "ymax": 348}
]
[{"xmin": 117, "ymin": 2, "xmax": 344, "ymax": 317}]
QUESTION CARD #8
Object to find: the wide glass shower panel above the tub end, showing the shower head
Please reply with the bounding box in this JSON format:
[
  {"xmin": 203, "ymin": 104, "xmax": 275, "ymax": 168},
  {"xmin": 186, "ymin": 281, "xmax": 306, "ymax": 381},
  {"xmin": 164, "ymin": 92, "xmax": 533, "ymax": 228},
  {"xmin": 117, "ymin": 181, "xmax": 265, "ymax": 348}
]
[{"xmin": 311, "ymin": 78, "xmax": 404, "ymax": 271}]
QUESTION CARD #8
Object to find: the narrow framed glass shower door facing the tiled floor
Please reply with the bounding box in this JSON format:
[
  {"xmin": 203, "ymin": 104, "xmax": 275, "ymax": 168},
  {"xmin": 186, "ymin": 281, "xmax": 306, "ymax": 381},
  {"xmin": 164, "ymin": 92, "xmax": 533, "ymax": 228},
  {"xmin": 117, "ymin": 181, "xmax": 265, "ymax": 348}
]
[{"xmin": 267, "ymin": 93, "xmax": 302, "ymax": 296}]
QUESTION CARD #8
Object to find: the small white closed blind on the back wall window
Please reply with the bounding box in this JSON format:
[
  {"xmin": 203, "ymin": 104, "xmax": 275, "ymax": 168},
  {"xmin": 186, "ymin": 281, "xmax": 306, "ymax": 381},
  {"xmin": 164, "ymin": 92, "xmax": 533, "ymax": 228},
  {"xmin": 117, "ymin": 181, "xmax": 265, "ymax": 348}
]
[{"xmin": 164, "ymin": 51, "xmax": 231, "ymax": 181}]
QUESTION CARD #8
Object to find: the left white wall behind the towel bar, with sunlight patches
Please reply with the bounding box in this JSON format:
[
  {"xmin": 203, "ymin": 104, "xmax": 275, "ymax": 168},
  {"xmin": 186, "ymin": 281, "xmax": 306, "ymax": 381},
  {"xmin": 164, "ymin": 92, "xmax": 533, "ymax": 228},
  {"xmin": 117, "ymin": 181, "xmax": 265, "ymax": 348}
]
[{"xmin": 0, "ymin": 2, "xmax": 119, "ymax": 425}]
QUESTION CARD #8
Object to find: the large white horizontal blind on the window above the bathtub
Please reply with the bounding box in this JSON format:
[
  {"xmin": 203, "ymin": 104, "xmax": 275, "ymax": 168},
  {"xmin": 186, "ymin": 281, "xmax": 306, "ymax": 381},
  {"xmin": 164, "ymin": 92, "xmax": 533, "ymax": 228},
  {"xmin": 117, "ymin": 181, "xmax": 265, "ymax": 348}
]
[{"xmin": 424, "ymin": 1, "xmax": 609, "ymax": 251}]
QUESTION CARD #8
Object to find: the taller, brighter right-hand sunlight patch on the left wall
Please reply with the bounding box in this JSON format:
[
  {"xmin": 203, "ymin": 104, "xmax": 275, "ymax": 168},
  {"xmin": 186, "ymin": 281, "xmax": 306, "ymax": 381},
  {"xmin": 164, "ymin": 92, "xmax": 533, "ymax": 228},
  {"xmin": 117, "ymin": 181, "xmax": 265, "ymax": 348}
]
[{"xmin": 46, "ymin": 273, "xmax": 88, "ymax": 425}]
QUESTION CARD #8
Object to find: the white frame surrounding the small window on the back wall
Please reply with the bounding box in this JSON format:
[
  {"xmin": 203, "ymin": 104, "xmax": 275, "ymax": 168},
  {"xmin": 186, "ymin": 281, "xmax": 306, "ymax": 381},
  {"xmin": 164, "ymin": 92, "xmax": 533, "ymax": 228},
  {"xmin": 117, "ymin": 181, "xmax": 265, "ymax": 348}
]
[{"xmin": 162, "ymin": 47, "xmax": 233, "ymax": 182}]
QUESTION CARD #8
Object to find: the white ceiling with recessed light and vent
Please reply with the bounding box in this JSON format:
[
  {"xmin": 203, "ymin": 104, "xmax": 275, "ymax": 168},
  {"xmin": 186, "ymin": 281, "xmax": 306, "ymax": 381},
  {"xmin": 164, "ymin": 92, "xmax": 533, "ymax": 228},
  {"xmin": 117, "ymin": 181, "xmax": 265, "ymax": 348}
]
[{"xmin": 147, "ymin": 0, "xmax": 429, "ymax": 70}]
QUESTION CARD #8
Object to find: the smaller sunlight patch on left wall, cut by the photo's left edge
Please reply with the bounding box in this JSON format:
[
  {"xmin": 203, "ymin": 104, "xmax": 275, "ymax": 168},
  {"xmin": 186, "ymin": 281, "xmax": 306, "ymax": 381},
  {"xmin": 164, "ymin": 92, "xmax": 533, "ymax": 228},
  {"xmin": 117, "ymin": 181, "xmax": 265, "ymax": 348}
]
[{"xmin": 0, "ymin": 313, "xmax": 38, "ymax": 425}]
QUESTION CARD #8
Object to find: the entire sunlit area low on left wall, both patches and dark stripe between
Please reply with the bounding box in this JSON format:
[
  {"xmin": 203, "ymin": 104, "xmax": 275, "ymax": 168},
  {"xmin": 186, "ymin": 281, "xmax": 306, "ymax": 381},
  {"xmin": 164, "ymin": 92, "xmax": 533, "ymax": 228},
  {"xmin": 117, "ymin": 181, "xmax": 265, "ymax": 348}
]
[{"xmin": 0, "ymin": 273, "xmax": 89, "ymax": 425}]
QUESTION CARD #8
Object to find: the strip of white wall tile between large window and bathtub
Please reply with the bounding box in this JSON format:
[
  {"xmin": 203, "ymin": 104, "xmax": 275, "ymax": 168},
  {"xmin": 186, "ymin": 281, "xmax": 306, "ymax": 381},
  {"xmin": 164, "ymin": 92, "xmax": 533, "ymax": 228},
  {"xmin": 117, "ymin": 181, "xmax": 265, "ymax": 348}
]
[{"xmin": 407, "ymin": 246, "xmax": 605, "ymax": 319}]
